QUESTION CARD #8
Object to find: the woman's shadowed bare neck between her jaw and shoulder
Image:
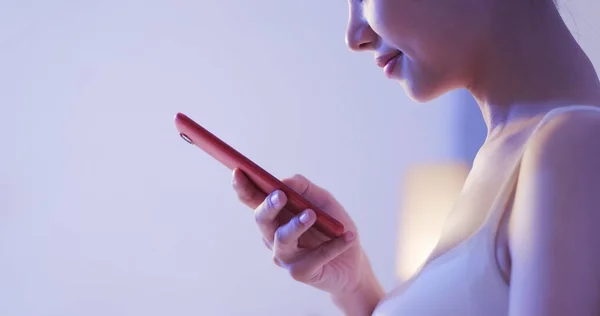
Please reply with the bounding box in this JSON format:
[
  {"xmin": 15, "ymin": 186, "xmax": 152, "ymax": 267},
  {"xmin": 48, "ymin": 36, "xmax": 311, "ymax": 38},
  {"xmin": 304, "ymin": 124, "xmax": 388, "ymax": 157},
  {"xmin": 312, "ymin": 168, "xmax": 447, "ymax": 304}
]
[{"xmin": 468, "ymin": 0, "xmax": 600, "ymax": 137}]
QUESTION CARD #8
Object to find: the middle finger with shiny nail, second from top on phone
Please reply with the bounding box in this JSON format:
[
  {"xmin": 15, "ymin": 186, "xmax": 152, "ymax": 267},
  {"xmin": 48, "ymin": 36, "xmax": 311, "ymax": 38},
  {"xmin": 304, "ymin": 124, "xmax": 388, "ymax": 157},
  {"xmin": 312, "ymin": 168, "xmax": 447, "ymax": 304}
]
[{"xmin": 254, "ymin": 190, "xmax": 287, "ymax": 243}]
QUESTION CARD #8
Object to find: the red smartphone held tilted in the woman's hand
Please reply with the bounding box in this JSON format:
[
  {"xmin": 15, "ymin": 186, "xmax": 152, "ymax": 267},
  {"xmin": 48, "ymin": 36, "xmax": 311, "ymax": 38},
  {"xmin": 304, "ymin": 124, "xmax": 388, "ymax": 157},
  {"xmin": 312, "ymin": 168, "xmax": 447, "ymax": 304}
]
[{"xmin": 175, "ymin": 113, "xmax": 344, "ymax": 238}]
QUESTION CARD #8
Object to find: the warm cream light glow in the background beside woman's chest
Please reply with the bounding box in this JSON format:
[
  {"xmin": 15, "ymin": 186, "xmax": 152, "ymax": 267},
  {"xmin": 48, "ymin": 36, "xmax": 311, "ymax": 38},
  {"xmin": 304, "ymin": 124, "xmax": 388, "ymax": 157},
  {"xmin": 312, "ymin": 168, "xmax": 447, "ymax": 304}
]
[{"xmin": 396, "ymin": 163, "xmax": 469, "ymax": 281}]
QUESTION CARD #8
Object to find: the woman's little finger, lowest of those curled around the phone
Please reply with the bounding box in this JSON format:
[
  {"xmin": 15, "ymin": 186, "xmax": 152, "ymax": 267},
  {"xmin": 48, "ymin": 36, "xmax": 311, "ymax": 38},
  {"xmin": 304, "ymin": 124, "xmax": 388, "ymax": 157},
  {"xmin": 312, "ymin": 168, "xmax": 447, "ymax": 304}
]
[{"xmin": 288, "ymin": 232, "xmax": 356, "ymax": 281}]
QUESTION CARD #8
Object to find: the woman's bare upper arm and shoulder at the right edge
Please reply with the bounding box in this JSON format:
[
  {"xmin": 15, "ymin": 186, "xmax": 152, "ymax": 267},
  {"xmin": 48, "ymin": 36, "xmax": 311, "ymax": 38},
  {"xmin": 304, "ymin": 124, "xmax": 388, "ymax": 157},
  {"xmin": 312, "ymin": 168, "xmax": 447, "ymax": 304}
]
[{"xmin": 509, "ymin": 112, "xmax": 600, "ymax": 316}]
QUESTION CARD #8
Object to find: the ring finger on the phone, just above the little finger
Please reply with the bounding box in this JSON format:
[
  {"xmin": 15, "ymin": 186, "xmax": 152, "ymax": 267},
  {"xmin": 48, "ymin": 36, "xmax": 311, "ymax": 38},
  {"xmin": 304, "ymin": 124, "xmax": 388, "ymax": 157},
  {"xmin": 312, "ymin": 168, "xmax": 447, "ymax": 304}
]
[{"xmin": 273, "ymin": 210, "xmax": 317, "ymax": 252}]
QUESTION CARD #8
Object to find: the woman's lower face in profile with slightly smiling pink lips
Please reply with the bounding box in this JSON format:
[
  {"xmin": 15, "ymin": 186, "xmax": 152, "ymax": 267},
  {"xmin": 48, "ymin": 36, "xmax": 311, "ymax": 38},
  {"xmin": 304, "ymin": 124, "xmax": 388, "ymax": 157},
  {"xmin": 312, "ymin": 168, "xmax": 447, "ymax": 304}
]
[{"xmin": 346, "ymin": 0, "xmax": 489, "ymax": 102}]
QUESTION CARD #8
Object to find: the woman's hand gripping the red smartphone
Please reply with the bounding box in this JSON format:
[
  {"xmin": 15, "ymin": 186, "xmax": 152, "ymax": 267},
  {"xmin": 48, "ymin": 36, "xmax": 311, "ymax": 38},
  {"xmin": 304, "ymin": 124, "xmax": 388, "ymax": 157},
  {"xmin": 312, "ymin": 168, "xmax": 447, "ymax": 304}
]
[{"xmin": 233, "ymin": 169, "xmax": 377, "ymax": 296}]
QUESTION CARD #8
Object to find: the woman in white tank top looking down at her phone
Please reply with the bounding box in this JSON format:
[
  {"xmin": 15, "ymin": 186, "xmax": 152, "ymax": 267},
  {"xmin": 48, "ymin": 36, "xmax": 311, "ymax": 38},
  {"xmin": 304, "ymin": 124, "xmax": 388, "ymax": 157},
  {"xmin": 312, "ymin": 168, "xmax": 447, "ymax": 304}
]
[{"xmin": 233, "ymin": 0, "xmax": 600, "ymax": 316}]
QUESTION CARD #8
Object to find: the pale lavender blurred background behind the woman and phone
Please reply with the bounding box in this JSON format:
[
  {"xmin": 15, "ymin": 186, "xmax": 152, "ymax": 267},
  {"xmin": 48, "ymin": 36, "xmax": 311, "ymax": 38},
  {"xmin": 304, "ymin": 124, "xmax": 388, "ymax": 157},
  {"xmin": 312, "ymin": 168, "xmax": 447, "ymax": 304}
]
[{"xmin": 0, "ymin": 0, "xmax": 600, "ymax": 316}]
